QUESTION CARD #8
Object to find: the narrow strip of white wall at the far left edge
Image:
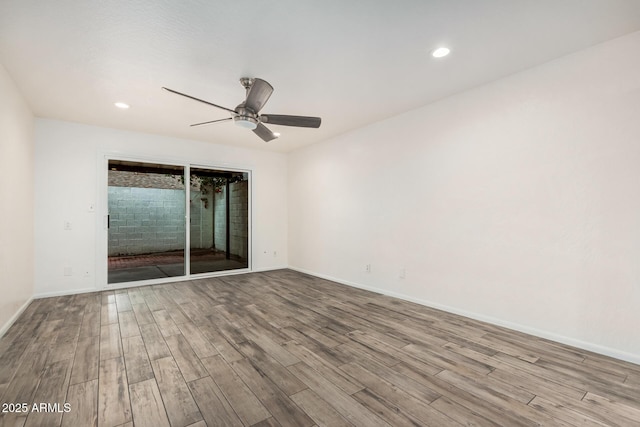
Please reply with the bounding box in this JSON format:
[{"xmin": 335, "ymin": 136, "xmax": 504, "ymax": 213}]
[{"xmin": 0, "ymin": 64, "xmax": 33, "ymax": 336}]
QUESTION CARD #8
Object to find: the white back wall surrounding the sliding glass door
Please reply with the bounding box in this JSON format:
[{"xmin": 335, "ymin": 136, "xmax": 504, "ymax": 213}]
[{"xmin": 35, "ymin": 119, "xmax": 287, "ymax": 296}]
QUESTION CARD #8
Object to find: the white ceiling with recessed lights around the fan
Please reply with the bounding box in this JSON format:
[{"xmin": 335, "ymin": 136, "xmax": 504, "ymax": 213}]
[{"xmin": 0, "ymin": 0, "xmax": 640, "ymax": 151}]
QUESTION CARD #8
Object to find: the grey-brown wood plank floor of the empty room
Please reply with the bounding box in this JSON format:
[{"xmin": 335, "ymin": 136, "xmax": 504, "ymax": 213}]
[{"xmin": 0, "ymin": 270, "xmax": 640, "ymax": 427}]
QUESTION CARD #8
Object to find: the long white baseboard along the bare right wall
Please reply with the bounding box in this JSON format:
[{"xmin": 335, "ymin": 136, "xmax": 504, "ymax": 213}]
[{"xmin": 289, "ymin": 266, "xmax": 640, "ymax": 365}]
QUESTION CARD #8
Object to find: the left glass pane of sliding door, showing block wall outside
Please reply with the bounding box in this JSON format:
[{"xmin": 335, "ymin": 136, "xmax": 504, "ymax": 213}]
[{"xmin": 108, "ymin": 160, "xmax": 186, "ymax": 283}]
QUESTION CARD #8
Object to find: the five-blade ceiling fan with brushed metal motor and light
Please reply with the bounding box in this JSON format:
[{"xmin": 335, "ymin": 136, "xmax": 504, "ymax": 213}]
[{"xmin": 162, "ymin": 77, "xmax": 321, "ymax": 142}]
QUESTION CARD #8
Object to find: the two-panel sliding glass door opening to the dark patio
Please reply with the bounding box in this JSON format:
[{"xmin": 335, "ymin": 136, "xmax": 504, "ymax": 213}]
[{"xmin": 107, "ymin": 159, "xmax": 249, "ymax": 284}]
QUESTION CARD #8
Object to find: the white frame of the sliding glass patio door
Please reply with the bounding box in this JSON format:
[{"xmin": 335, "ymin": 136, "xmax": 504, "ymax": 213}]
[{"xmin": 95, "ymin": 152, "xmax": 253, "ymax": 290}]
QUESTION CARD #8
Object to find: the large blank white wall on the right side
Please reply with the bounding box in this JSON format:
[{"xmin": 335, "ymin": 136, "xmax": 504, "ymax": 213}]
[{"xmin": 289, "ymin": 33, "xmax": 640, "ymax": 363}]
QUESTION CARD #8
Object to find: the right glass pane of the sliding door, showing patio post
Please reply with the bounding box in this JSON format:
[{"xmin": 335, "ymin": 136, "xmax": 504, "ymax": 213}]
[{"xmin": 189, "ymin": 168, "xmax": 249, "ymax": 274}]
